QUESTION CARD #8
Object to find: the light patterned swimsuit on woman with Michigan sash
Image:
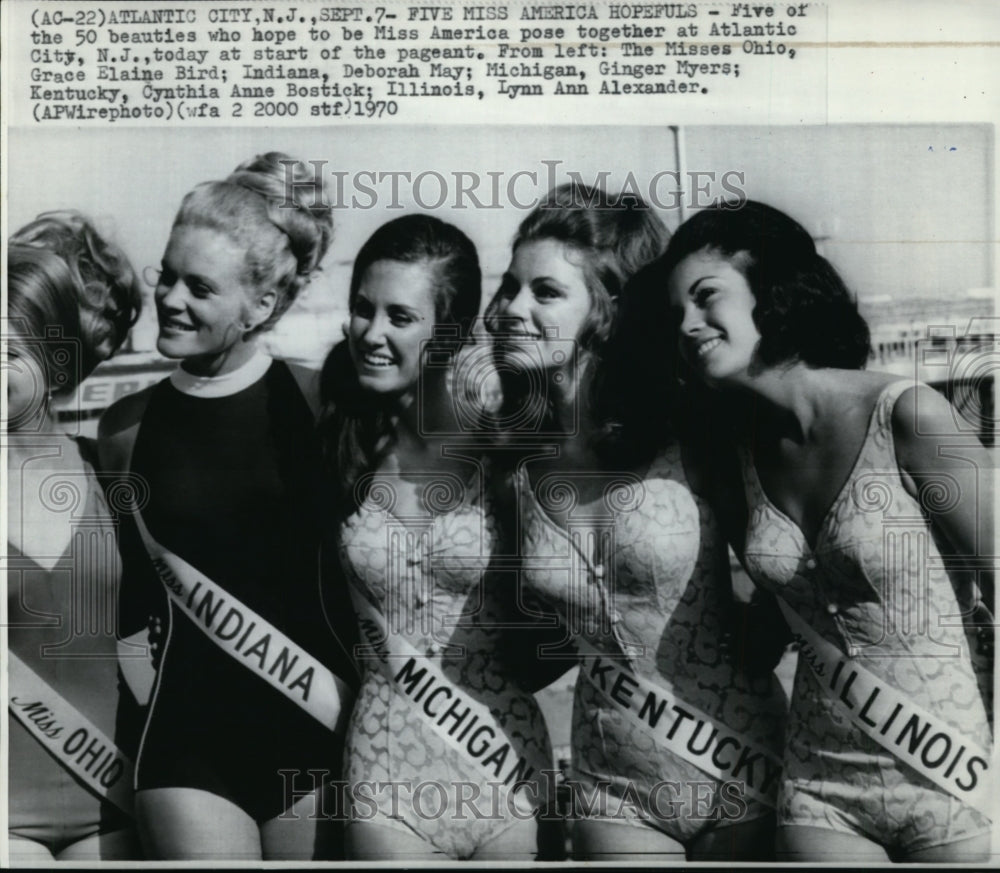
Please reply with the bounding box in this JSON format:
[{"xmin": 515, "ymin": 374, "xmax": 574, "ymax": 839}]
[{"xmin": 340, "ymin": 460, "xmax": 552, "ymax": 858}]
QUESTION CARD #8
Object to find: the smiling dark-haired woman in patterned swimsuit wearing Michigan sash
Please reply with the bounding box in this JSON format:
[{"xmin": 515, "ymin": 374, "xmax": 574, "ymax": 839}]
[{"xmin": 324, "ymin": 215, "xmax": 552, "ymax": 860}]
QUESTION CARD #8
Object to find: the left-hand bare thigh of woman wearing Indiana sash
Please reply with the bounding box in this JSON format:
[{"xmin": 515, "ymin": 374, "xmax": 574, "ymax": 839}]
[{"xmin": 135, "ymin": 788, "xmax": 261, "ymax": 861}]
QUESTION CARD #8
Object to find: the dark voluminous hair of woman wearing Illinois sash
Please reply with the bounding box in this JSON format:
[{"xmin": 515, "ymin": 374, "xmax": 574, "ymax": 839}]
[{"xmin": 599, "ymin": 200, "xmax": 871, "ymax": 459}]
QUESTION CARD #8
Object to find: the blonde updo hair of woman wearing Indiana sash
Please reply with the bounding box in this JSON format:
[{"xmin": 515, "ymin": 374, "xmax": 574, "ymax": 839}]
[{"xmin": 174, "ymin": 152, "xmax": 333, "ymax": 333}]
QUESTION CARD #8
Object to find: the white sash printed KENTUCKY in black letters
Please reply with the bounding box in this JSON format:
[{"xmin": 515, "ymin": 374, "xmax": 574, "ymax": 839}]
[{"xmin": 578, "ymin": 639, "xmax": 781, "ymax": 807}]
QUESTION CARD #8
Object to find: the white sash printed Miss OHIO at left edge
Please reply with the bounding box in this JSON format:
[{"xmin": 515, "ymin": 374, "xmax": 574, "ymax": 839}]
[{"xmin": 7, "ymin": 652, "xmax": 132, "ymax": 815}]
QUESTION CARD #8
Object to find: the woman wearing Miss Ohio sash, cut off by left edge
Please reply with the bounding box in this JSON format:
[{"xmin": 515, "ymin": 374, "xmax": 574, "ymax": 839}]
[{"xmin": 4, "ymin": 211, "xmax": 140, "ymax": 865}]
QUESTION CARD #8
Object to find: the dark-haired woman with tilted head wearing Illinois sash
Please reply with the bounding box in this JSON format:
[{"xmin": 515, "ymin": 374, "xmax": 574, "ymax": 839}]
[{"xmin": 640, "ymin": 202, "xmax": 993, "ymax": 862}]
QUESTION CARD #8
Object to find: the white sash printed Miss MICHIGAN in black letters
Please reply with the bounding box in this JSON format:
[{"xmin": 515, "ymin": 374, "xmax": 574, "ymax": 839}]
[{"xmin": 348, "ymin": 582, "xmax": 552, "ymax": 796}]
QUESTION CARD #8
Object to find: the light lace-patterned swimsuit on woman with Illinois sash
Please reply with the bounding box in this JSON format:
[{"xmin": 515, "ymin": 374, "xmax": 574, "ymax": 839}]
[{"xmin": 742, "ymin": 382, "xmax": 991, "ymax": 850}]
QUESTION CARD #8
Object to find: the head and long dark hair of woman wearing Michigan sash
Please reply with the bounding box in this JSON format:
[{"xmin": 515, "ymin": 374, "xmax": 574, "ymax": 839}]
[{"xmin": 321, "ymin": 215, "xmax": 481, "ymax": 513}]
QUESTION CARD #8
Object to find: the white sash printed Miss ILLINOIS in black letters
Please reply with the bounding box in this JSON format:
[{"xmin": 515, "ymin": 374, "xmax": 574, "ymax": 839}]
[{"xmin": 777, "ymin": 597, "xmax": 993, "ymax": 817}]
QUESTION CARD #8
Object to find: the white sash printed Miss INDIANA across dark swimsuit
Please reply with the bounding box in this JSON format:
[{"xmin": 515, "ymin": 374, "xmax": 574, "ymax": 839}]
[{"xmin": 133, "ymin": 509, "xmax": 351, "ymax": 731}]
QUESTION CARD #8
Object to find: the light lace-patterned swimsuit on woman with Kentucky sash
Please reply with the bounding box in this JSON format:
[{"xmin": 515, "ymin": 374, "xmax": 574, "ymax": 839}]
[{"xmin": 519, "ymin": 447, "xmax": 784, "ymax": 842}]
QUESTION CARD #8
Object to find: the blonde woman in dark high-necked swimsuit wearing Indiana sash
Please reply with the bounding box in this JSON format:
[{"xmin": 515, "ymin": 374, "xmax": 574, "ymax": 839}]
[{"xmin": 101, "ymin": 153, "xmax": 354, "ymax": 860}]
